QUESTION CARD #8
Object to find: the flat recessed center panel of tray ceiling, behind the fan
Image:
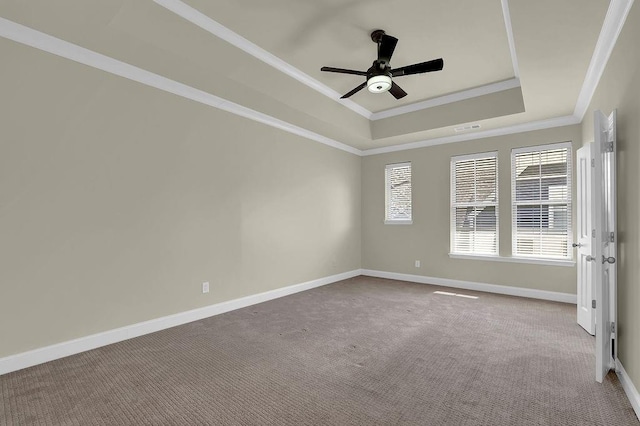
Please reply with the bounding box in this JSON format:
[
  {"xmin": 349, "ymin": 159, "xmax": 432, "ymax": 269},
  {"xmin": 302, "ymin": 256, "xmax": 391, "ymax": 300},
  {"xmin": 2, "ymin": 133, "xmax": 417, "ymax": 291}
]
[{"xmin": 185, "ymin": 0, "xmax": 515, "ymax": 112}]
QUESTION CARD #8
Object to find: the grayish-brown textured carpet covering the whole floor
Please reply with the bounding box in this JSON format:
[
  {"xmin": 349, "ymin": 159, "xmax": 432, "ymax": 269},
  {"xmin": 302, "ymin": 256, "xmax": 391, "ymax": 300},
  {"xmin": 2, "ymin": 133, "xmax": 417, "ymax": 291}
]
[{"xmin": 0, "ymin": 277, "xmax": 639, "ymax": 426}]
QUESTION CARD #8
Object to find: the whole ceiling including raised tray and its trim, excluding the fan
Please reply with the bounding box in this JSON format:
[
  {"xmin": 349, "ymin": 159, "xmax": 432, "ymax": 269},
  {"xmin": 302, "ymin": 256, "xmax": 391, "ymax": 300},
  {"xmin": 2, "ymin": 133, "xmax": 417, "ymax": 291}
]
[{"xmin": 0, "ymin": 0, "xmax": 625, "ymax": 150}]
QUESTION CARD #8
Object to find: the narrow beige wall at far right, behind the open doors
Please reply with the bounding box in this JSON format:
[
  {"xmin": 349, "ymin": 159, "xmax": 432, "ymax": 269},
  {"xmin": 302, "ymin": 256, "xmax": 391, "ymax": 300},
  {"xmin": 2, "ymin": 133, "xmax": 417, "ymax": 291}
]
[{"xmin": 582, "ymin": 2, "xmax": 640, "ymax": 396}]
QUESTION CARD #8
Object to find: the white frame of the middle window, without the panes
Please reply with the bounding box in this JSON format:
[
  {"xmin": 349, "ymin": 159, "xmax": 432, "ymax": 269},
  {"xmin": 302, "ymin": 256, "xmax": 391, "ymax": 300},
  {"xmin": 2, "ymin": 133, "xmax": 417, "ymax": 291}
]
[{"xmin": 449, "ymin": 151, "xmax": 500, "ymax": 255}]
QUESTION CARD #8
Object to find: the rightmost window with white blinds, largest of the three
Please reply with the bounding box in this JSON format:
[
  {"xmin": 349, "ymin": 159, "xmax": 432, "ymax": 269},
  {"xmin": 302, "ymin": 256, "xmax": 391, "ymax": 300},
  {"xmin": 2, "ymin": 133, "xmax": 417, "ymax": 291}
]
[{"xmin": 511, "ymin": 142, "xmax": 572, "ymax": 259}]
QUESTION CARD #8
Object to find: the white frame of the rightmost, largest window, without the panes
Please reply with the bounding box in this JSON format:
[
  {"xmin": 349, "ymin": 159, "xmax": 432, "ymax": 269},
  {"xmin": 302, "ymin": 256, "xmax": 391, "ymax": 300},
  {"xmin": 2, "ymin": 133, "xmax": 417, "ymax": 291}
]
[{"xmin": 511, "ymin": 142, "xmax": 574, "ymax": 265}]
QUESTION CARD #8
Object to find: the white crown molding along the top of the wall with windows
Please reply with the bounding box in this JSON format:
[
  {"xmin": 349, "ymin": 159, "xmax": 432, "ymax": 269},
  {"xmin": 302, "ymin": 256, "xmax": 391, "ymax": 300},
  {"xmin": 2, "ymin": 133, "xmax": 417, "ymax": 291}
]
[{"xmin": 362, "ymin": 115, "xmax": 580, "ymax": 157}]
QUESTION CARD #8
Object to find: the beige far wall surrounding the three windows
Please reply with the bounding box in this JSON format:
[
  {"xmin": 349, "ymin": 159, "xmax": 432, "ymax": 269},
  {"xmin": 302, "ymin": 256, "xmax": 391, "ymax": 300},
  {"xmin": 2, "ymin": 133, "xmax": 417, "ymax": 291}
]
[{"xmin": 362, "ymin": 125, "xmax": 581, "ymax": 293}]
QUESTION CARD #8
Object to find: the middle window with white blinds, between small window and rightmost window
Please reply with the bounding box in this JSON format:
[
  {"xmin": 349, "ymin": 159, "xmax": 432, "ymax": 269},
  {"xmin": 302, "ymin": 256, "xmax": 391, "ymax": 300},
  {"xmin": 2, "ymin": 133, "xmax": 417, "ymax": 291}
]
[{"xmin": 451, "ymin": 152, "xmax": 498, "ymax": 256}]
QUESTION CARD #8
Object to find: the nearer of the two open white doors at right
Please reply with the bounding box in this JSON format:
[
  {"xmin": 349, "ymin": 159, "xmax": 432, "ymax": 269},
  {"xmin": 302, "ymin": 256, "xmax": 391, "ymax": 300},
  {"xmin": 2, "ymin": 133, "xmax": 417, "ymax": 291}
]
[{"xmin": 592, "ymin": 111, "xmax": 618, "ymax": 382}]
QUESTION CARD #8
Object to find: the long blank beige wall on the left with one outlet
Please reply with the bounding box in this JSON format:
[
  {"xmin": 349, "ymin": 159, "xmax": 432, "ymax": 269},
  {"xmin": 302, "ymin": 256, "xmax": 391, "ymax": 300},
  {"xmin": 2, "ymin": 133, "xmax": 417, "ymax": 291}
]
[{"xmin": 0, "ymin": 40, "xmax": 361, "ymax": 357}]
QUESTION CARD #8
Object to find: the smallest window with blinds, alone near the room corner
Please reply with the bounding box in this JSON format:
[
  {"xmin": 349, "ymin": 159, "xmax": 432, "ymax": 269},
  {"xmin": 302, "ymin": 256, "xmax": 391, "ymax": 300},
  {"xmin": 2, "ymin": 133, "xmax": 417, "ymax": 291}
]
[{"xmin": 384, "ymin": 163, "xmax": 412, "ymax": 224}]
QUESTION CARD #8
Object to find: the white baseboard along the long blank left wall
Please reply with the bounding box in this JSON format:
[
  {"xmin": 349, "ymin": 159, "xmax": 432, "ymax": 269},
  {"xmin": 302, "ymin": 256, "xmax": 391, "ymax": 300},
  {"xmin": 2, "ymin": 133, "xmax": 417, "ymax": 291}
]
[{"xmin": 0, "ymin": 269, "xmax": 362, "ymax": 375}]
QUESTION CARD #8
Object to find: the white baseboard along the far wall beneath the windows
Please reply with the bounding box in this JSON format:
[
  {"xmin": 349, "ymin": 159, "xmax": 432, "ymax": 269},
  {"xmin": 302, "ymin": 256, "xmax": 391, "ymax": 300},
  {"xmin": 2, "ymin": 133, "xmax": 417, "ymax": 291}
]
[{"xmin": 362, "ymin": 269, "xmax": 578, "ymax": 304}]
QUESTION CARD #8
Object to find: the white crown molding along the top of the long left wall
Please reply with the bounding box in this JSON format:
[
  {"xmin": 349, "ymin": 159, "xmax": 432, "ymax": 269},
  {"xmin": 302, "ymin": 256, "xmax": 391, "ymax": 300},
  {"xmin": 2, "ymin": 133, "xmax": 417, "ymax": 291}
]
[{"xmin": 0, "ymin": 17, "xmax": 362, "ymax": 155}]
